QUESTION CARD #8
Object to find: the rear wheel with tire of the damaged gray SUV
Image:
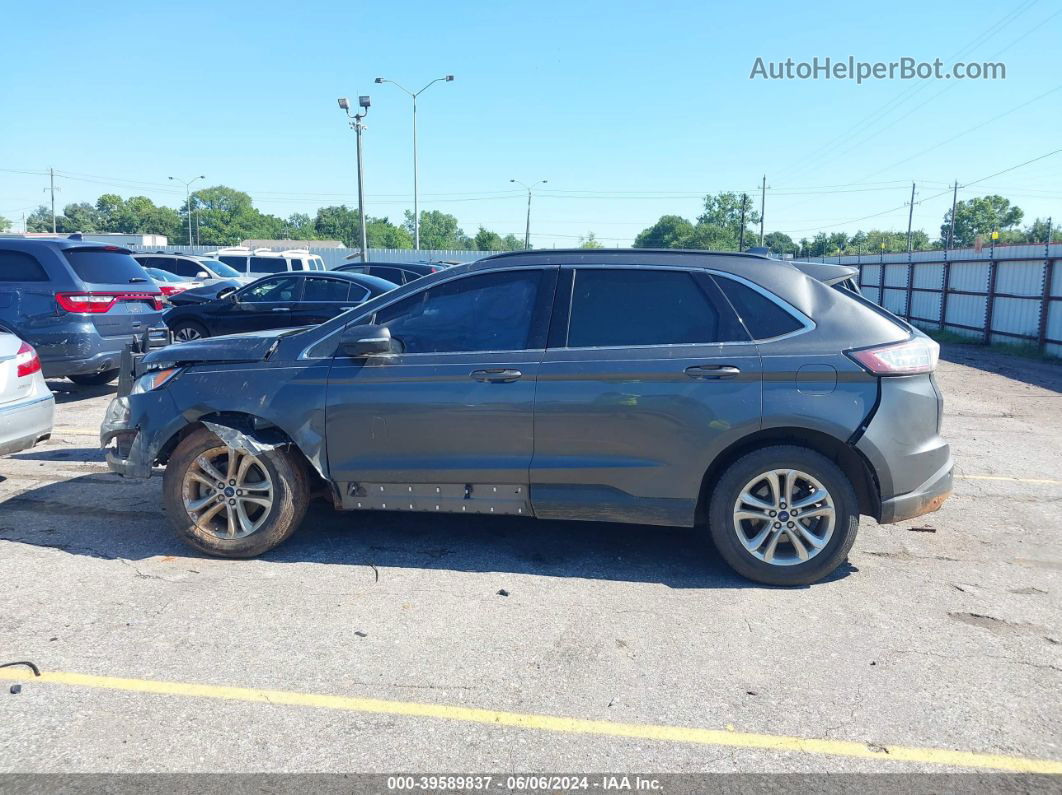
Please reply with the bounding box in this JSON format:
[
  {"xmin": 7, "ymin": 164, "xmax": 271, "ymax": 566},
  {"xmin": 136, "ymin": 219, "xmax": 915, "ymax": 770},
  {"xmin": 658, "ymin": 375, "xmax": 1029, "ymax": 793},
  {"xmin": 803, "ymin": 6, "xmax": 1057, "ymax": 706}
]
[{"xmin": 708, "ymin": 445, "xmax": 859, "ymax": 585}]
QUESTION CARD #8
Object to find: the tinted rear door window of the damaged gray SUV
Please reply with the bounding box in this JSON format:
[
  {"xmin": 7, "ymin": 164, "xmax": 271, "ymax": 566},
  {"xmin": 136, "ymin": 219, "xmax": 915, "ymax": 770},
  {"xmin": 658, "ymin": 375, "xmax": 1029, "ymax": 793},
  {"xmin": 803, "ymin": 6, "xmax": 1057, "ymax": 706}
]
[{"xmin": 568, "ymin": 269, "xmax": 735, "ymax": 348}]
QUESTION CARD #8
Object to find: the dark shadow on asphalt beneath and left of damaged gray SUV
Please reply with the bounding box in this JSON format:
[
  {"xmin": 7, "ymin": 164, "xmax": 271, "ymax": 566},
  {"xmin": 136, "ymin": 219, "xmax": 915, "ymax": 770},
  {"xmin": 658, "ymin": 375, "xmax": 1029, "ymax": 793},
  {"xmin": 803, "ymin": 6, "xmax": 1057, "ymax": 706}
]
[{"xmin": 0, "ymin": 474, "xmax": 856, "ymax": 589}]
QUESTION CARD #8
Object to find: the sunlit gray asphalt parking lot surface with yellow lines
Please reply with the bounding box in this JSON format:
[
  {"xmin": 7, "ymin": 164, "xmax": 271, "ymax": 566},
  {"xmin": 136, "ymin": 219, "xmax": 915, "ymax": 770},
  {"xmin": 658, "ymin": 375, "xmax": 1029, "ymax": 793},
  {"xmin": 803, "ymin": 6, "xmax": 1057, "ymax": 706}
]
[{"xmin": 0, "ymin": 347, "xmax": 1062, "ymax": 773}]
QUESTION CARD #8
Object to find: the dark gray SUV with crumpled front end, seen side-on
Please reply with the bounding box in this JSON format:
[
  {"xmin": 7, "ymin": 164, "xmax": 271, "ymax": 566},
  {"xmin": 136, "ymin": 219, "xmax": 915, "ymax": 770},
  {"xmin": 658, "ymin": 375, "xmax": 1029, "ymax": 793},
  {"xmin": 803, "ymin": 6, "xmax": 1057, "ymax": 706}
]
[{"xmin": 101, "ymin": 249, "xmax": 952, "ymax": 585}]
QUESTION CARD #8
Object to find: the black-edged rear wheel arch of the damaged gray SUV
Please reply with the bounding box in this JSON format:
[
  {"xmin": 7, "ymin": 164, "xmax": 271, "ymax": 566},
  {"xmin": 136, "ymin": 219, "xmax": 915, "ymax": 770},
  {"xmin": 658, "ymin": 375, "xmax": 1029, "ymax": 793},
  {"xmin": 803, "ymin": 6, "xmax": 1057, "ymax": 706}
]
[{"xmin": 695, "ymin": 427, "xmax": 881, "ymax": 524}]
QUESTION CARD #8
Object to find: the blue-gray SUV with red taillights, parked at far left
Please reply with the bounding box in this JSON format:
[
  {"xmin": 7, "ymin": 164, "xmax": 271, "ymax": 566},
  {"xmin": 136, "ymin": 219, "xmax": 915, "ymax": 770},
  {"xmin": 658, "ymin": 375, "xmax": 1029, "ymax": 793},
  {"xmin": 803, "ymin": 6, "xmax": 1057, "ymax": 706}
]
[{"xmin": 0, "ymin": 238, "xmax": 162, "ymax": 385}]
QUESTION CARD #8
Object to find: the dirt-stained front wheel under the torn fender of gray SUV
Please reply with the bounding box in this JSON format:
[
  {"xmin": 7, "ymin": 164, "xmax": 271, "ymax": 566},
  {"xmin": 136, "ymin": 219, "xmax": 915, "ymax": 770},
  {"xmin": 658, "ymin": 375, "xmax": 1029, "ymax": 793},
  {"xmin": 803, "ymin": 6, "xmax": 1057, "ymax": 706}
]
[{"xmin": 162, "ymin": 428, "xmax": 309, "ymax": 557}]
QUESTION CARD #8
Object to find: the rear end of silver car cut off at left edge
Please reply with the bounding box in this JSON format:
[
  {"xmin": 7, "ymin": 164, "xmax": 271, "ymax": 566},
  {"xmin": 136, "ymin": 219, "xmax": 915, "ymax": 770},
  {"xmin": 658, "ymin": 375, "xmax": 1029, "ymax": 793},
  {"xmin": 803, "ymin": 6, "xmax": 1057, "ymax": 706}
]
[{"xmin": 0, "ymin": 331, "xmax": 55, "ymax": 455}]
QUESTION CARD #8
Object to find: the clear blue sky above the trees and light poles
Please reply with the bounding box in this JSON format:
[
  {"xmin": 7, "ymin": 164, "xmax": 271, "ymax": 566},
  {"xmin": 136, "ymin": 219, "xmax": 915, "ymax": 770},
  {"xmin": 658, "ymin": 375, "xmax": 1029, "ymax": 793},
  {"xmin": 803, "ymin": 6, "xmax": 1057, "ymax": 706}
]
[{"xmin": 0, "ymin": 0, "xmax": 1062, "ymax": 246}]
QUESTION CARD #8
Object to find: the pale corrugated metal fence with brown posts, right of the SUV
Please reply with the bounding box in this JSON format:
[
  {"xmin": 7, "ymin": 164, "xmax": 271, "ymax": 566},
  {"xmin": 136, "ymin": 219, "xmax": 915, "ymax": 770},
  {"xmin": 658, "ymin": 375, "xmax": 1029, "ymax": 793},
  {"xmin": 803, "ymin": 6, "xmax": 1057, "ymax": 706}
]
[{"xmin": 823, "ymin": 243, "xmax": 1062, "ymax": 357}]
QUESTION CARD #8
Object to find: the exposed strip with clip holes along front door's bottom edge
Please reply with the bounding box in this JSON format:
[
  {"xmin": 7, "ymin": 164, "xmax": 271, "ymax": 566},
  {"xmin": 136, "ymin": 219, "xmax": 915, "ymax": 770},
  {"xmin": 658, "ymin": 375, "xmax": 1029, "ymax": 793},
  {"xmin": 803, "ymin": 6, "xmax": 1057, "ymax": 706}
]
[{"xmin": 340, "ymin": 483, "xmax": 531, "ymax": 516}]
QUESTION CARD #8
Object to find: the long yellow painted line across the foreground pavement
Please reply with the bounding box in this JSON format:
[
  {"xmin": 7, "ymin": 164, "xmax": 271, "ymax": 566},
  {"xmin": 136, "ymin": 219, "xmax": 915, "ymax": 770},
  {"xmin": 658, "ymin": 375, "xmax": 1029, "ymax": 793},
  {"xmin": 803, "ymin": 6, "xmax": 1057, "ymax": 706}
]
[{"xmin": 0, "ymin": 669, "xmax": 1062, "ymax": 775}]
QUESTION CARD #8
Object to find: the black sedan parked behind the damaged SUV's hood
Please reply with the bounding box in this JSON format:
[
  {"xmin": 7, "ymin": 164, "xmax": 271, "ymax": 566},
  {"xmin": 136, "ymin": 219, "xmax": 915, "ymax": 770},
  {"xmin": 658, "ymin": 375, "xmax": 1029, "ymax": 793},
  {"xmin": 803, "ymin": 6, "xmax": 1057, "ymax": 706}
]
[{"xmin": 162, "ymin": 272, "xmax": 396, "ymax": 342}]
